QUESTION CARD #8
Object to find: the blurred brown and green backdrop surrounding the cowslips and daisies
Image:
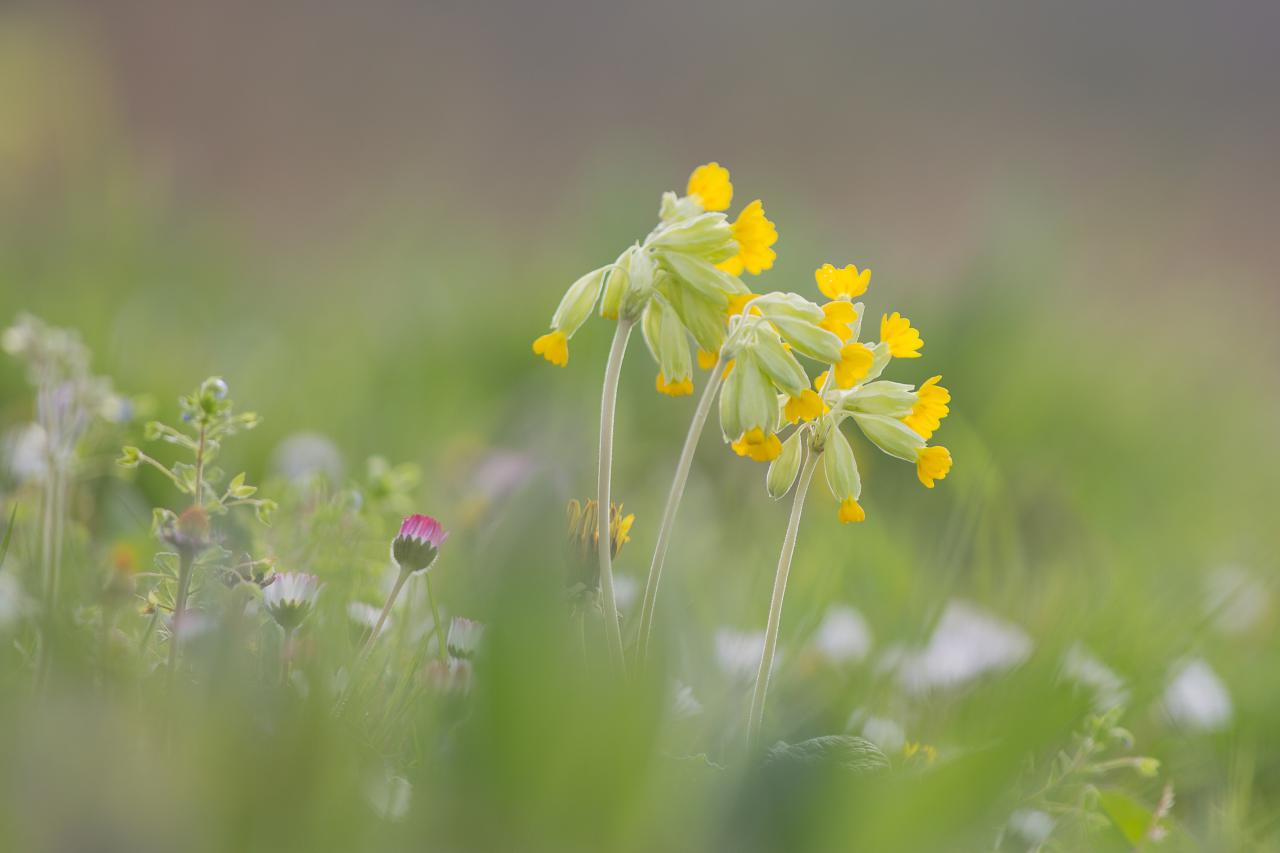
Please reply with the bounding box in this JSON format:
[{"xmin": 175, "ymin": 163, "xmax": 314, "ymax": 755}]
[{"xmin": 0, "ymin": 0, "xmax": 1280, "ymax": 849}]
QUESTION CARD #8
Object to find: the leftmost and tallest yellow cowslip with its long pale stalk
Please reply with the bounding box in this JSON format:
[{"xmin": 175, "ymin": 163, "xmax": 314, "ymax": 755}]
[{"xmin": 532, "ymin": 163, "xmax": 778, "ymax": 669}]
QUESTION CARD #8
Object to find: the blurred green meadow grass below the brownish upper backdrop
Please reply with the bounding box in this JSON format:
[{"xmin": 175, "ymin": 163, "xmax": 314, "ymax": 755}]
[{"xmin": 0, "ymin": 11, "xmax": 1280, "ymax": 850}]
